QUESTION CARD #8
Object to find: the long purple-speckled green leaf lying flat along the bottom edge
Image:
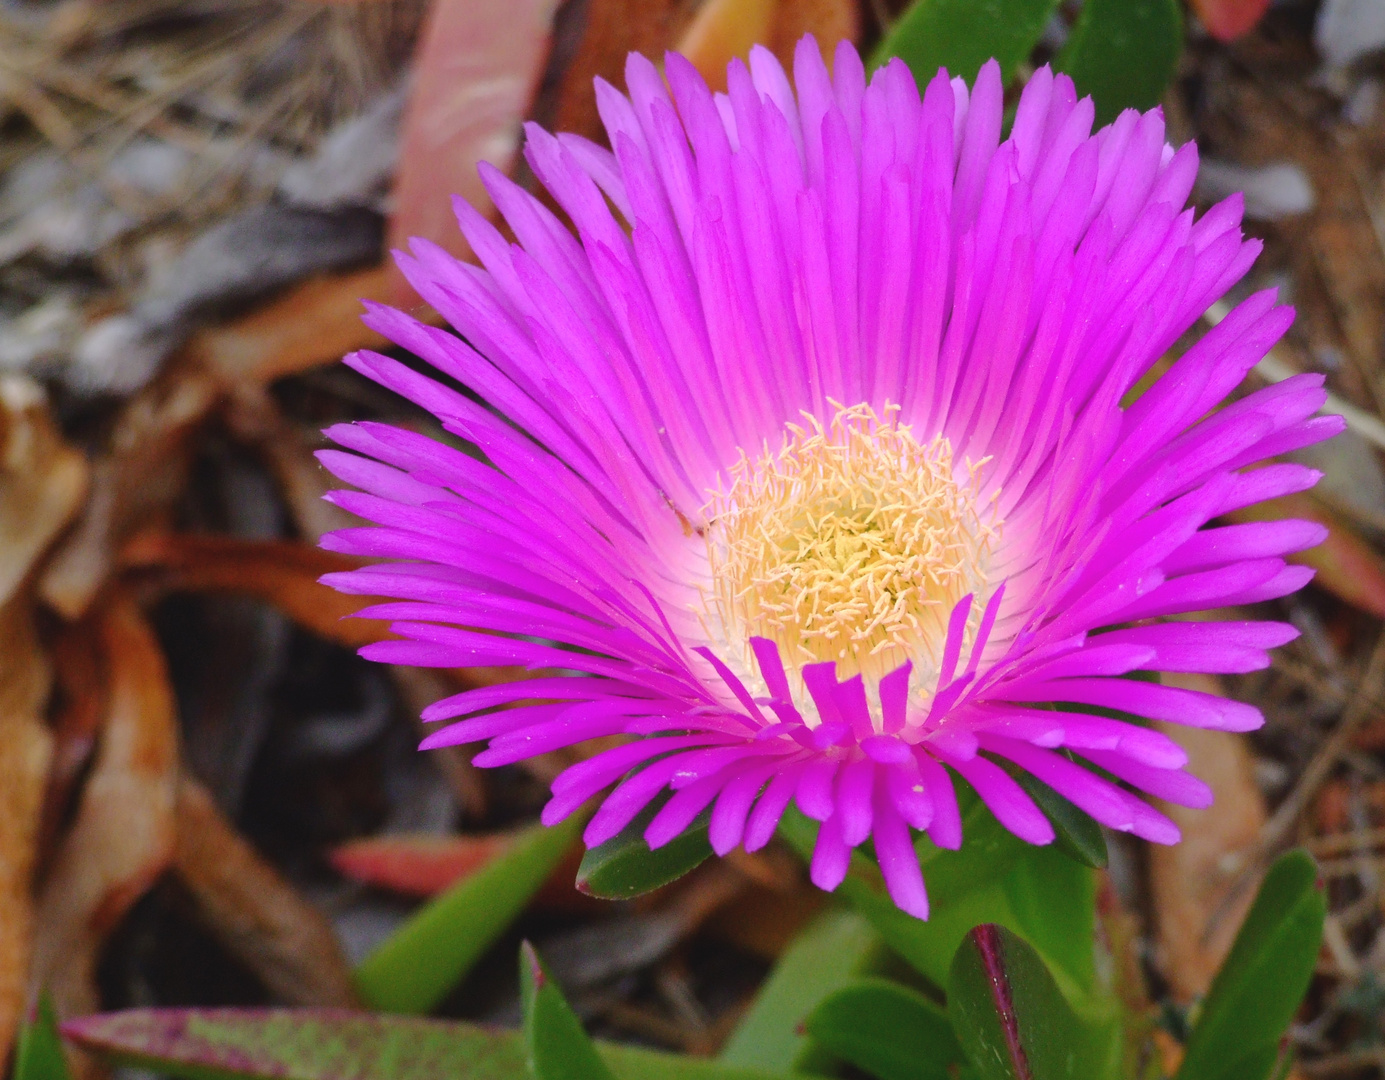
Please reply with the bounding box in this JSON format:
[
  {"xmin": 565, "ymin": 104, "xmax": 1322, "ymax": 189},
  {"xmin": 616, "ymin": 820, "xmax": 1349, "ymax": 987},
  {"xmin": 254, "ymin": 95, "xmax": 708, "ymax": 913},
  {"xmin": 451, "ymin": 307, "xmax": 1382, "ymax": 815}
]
[{"xmin": 62, "ymin": 1008, "xmax": 792, "ymax": 1080}]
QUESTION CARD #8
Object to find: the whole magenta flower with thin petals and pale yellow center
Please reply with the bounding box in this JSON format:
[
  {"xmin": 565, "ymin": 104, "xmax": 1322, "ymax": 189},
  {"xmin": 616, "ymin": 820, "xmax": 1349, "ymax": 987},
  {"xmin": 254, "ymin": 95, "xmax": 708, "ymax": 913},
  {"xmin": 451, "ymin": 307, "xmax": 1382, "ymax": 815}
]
[{"xmin": 321, "ymin": 39, "xmax": 1341, "ymax": 917}]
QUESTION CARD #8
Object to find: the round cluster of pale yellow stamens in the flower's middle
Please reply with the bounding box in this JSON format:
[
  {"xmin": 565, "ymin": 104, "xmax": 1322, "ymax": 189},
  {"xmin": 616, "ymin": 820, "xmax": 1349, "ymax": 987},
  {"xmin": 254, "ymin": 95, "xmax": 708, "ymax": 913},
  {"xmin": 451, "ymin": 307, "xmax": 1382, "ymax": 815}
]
[{"xmin": 705, "ymin": 403, "xmax": 996, "ymax": 690}]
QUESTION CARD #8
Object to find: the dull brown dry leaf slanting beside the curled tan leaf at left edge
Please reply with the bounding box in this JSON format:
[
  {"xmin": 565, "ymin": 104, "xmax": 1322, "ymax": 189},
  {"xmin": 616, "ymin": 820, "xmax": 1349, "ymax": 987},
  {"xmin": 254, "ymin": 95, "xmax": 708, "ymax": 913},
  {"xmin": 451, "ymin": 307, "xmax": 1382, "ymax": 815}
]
[{"xmin": 39, "ymin": 370, "xmax": 219, "ymax": 619}]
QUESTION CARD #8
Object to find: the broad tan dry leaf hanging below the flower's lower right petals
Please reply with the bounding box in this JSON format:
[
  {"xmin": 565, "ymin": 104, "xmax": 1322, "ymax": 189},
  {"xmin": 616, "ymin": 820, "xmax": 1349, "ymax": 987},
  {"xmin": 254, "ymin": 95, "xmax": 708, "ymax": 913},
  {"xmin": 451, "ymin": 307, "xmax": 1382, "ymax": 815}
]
[{"xmin": 1150, "ymin": 674, "xmax": 1266, "ymax": 1002}]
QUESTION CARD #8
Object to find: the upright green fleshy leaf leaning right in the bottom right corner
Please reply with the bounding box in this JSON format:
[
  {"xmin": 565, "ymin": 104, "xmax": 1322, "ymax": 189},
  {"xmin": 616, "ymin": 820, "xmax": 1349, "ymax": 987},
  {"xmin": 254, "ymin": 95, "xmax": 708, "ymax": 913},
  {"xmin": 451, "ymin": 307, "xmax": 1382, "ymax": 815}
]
[{"xmin": 1177, "ymin": 850, "xmax": 1327, "ymax": 1080}]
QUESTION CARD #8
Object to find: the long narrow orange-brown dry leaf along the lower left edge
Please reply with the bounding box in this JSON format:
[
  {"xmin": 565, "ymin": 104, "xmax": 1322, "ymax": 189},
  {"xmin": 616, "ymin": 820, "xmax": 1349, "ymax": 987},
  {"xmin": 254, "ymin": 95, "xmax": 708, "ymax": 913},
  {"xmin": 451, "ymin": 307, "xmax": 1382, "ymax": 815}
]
[{"xmin": 0, "ymin": 594, "xmax": 53, "ymax": 1061}]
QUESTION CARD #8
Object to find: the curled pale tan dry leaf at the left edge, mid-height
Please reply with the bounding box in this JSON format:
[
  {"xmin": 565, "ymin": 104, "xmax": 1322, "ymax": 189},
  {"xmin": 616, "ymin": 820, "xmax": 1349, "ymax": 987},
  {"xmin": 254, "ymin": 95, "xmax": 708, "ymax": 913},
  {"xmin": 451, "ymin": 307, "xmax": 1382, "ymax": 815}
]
[{"xmin": 0, "ymin": 375, "xmax": 89, "ymax": 605}]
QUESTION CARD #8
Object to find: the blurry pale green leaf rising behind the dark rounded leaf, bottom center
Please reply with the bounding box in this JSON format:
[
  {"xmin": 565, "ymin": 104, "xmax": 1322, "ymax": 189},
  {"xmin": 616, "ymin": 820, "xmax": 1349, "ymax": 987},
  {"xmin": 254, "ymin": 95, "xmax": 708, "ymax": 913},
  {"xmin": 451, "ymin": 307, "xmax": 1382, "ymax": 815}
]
[{"xmin": 720, "ymin": 911, "xmax": 888, "ymax": 1073}]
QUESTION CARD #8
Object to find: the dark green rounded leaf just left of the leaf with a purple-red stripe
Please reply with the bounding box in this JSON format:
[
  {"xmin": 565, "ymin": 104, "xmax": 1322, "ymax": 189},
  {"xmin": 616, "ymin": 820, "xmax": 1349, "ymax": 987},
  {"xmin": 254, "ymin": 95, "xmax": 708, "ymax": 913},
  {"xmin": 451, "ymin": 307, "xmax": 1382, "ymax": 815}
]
[{"xmin": 807, "ymin": 979, "xmax": 964, "ymax": 1080}]
